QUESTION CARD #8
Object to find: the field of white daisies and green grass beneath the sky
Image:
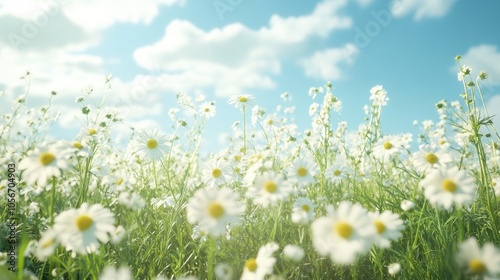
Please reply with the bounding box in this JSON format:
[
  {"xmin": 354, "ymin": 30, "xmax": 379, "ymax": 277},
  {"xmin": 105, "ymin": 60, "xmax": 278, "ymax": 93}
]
[{"xmin": 0, "ymin": 57, "xmax": 500, "ymax": 280}]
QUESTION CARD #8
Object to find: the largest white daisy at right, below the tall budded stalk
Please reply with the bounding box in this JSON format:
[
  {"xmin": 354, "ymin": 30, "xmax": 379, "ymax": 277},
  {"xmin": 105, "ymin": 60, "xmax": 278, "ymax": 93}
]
[{"xmin": 419, "ymin": 166, "xmax": 476, "ymax": 210}]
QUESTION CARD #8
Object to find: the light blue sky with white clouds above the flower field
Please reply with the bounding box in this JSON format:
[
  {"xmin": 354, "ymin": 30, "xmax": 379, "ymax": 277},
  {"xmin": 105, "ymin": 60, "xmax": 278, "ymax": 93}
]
[{"xmin": 0, "ymin": 0, "xmax": 500, "ymax": 150}]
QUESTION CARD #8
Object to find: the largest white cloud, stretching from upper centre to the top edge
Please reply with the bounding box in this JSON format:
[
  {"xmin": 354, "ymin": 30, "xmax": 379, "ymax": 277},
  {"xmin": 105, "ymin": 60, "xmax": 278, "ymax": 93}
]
[{"xmin": 134, "ymin": 0, "xmax": 352, "ymax": 96}]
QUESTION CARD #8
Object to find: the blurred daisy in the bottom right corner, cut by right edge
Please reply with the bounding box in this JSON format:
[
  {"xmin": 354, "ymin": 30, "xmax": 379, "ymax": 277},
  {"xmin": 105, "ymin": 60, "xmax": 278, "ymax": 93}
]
[{"xmin": 455, "ymin": 237, "xmax": 500, "ymax": 279}]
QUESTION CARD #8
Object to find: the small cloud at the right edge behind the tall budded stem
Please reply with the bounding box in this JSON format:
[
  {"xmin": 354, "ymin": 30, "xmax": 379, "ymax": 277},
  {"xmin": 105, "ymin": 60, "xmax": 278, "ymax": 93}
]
[{"xmin": 454, "ymin": 44, "xmax": 500, "ymax": 85}]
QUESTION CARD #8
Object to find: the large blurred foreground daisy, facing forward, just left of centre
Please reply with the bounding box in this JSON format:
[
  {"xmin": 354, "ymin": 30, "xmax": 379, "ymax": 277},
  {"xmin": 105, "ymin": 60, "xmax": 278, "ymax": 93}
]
[{"xmin": 186, "ymin": 188, "xmax": 245, "ymax": 236}]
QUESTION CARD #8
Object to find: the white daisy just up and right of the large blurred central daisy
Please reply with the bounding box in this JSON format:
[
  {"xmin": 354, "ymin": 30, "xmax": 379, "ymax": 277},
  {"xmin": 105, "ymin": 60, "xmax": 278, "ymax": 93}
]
[{"xmin": 247, "ymin": 171, "xmax": 292, "ymax": 207}]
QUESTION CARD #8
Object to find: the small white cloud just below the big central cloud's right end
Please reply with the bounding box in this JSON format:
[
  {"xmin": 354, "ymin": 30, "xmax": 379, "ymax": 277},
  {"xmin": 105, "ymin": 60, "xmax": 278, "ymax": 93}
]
[{"xmin": 302, "ymin": 44, "xmax": 359, "ymax": 80}]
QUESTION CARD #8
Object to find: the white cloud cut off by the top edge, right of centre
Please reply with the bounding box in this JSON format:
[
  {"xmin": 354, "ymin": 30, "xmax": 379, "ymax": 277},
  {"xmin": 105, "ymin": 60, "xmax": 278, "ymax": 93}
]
[{"xmin": 391, "ymin": 0, "xmax": 456, "ymax": 20}]
